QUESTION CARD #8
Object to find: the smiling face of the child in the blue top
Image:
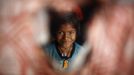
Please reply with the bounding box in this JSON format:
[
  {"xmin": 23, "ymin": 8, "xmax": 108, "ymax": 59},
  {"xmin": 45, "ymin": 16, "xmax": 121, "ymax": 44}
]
[{"xmin": 56, "ymin": 23, "xmax": 76, "ymax": 48}]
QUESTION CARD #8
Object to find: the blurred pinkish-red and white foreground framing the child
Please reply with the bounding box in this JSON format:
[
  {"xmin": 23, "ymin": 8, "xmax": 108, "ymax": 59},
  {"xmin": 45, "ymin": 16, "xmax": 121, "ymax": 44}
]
[{"xmin": 0, "ymin": 0, "xmax": 134, "ymax": 75}]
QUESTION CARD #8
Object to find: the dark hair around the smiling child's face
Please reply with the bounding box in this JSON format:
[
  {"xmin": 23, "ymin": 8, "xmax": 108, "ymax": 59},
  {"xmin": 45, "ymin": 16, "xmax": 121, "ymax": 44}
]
[{"xmin": 50, "ymin": 13, "xmax": 80, "ymax": 38}]
